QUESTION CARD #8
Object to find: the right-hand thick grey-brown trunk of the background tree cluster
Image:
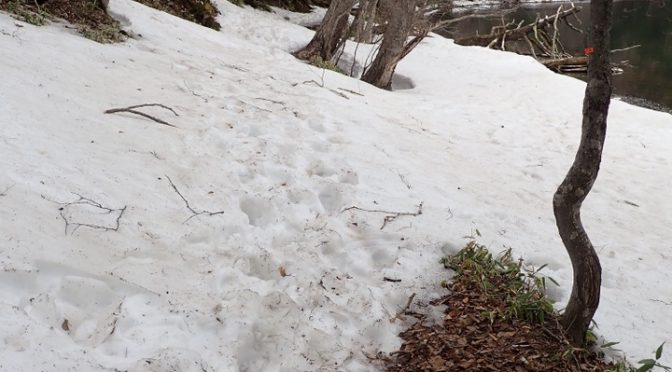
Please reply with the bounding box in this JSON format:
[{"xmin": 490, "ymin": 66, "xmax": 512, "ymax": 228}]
[{"xmin": 362, "ymin": 0, "xmax": 417, "ymax": 89}]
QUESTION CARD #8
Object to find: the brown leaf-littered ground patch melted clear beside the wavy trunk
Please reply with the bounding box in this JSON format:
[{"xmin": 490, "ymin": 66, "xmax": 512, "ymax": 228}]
[{"xmin": 382, "ymin": 243, "xmax": 615, "ymax": 372}]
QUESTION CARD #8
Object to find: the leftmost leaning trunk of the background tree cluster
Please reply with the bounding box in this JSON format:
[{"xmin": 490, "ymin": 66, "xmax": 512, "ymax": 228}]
[{"xmin": 294, "ymin": 0, "xmax": 357, "ymax": 61}]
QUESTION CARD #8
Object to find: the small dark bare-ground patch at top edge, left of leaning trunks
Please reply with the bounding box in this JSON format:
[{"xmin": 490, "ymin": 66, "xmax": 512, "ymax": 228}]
[{"xmin": 135, "ymin": 0, "xmax": 222, "ymax": 30}]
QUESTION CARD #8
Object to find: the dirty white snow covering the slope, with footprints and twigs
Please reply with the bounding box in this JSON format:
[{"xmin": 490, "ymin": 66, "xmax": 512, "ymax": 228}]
[{"xmin": 0, "ymin": 0, "xmax": 672, "ymax": 371}]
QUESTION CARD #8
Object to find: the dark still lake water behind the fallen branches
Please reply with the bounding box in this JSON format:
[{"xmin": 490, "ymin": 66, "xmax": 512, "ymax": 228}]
[{"xmin": 440, "ymin": 0, "xmax": 672, "ymax": 111}]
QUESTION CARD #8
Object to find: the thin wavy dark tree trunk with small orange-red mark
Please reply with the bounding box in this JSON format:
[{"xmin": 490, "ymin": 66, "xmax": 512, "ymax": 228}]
[{"xmin": 553, "ymin": 0, "xmax": 612, "ymax": 346}]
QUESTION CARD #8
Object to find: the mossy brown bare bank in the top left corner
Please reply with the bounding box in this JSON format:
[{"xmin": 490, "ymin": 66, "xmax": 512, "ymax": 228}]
[{"xmin": 0, "ymin": 0, "xmax": 128, "ymax": 43}]
